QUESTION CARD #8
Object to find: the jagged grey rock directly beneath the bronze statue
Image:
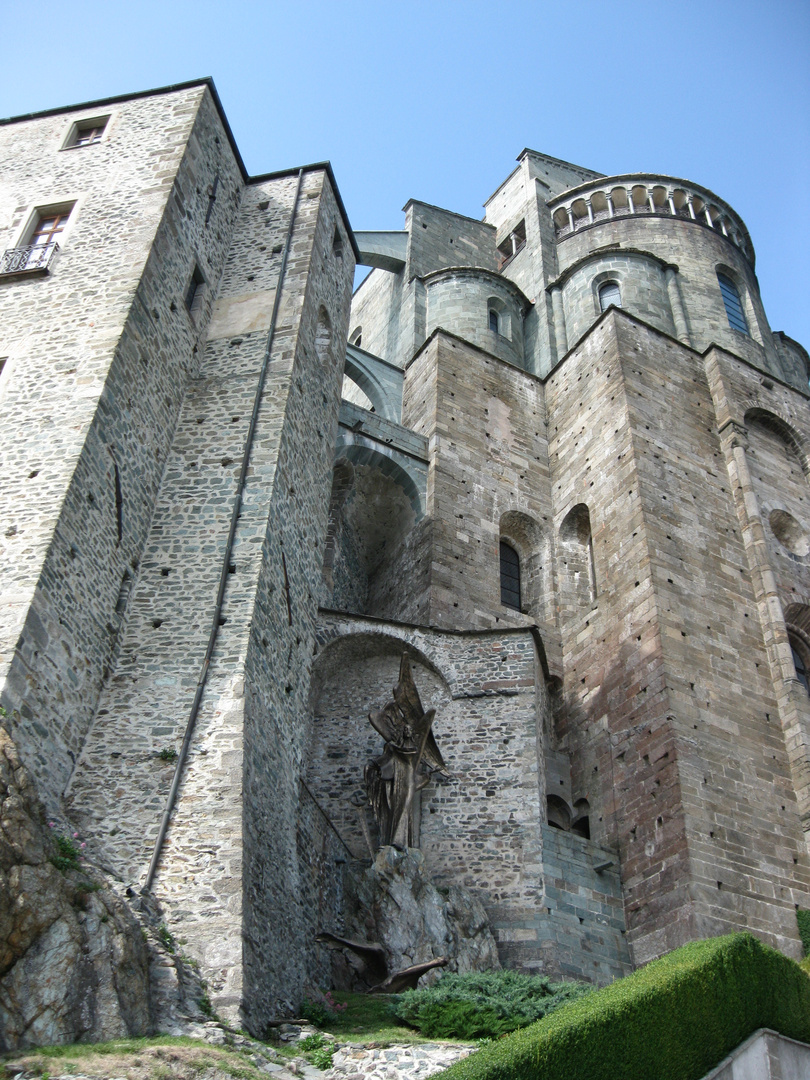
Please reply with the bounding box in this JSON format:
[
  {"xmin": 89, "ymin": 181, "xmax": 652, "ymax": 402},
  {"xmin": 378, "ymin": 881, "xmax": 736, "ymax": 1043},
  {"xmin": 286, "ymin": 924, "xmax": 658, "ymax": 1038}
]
[{"xmin": 336, "ymin": 847, "xmax": 500, "ymax": 985}]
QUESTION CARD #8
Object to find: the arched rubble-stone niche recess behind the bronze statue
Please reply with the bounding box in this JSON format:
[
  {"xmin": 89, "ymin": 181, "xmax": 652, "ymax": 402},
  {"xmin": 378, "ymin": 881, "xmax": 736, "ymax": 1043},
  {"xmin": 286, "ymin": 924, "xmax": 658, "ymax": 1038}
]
[{"xmin": 305, "ymin": 630, "xmax": 453, "ymax": 859}]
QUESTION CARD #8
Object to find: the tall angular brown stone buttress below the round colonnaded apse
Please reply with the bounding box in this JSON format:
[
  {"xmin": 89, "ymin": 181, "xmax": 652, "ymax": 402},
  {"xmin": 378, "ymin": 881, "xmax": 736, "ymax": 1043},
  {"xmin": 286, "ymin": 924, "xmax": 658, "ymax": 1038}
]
[{"xmin": 548, "ymin": 313, "xmax": 807, "ymax": 962}]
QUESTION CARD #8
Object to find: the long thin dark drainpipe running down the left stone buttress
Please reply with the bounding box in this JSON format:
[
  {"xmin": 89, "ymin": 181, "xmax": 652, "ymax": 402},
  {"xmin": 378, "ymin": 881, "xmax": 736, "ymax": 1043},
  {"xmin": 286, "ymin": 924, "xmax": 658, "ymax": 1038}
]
[{"xmin": 141, "ymin": 168, "xmax": 303, "ymax": 892}]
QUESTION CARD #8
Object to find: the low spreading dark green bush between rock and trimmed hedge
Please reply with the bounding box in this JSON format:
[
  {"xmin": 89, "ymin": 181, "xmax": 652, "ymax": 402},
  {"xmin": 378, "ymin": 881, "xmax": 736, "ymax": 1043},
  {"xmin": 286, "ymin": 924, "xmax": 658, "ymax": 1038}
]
[{"xmin": 394, "ymin": 971, "xmax": 593, "ymax": 1039}]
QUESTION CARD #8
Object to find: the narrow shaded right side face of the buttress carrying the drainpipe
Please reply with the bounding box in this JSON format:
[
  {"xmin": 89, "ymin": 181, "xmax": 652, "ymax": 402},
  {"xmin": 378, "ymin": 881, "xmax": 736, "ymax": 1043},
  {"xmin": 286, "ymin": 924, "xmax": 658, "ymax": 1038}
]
[{"xmin": 243, "ymin": 173, "xmax": 354, "ymax": 1031}]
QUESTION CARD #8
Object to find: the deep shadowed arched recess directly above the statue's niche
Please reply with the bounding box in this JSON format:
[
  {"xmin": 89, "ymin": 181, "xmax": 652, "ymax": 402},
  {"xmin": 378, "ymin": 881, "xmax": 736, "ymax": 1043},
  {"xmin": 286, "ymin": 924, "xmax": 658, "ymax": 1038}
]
[{"xmin": 323, "ymin": 443, "xmax": 427, "ymax": 619}]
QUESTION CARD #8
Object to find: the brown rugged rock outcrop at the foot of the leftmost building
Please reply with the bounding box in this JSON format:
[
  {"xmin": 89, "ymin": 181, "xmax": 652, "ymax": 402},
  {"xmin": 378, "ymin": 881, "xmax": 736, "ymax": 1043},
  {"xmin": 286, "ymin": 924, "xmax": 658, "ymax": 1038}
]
[{"xmin": 0, "ymin": 727, "xmax": 151, "ymax": 1050}]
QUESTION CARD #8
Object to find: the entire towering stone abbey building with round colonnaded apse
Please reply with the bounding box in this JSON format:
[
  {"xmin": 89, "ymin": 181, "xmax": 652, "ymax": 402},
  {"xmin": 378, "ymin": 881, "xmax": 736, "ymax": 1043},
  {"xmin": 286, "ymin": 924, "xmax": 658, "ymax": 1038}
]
[{"xmin": 0, "ymin": 80, "xmax": 810, "ymax": 1031}]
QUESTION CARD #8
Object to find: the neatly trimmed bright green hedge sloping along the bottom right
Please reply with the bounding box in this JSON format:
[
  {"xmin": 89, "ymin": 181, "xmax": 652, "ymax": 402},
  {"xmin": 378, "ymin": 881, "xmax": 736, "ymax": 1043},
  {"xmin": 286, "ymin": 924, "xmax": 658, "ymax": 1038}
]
[{"xmin": 442, "ymin": 934, "xmax": 810, "ymax": 1080}]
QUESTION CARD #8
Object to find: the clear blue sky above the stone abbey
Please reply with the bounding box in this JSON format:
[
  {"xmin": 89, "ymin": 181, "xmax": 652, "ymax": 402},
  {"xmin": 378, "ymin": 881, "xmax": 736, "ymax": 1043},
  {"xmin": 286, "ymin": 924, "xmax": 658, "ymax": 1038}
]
[{"xmin": 0, "ymin": 0, "xmax": 810, "ymax": 348}]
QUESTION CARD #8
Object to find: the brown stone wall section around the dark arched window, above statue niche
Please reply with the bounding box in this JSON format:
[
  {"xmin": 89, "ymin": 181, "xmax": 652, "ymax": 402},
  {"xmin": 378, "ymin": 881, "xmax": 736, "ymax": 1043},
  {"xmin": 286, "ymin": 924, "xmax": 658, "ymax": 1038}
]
[{"xmin": 403, "ymin": 332, "xmax": 553, "ymax": 629}]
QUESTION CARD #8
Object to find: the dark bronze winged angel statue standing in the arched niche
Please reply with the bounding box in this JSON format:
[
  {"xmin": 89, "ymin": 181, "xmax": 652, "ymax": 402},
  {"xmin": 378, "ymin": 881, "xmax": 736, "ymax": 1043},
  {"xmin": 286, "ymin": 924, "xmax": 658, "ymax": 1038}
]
[{"xmin": 363, "ymin": 654, "xmax": 447, "ymax": 848}]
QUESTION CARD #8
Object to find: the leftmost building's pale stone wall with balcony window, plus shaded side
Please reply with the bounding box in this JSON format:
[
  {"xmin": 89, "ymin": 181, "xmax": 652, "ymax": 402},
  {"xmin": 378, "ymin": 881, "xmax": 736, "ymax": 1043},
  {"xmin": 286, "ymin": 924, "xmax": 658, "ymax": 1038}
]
[{"xmin": 0, "ymin": 86, "xmax": 241, "ymax": 809}]
